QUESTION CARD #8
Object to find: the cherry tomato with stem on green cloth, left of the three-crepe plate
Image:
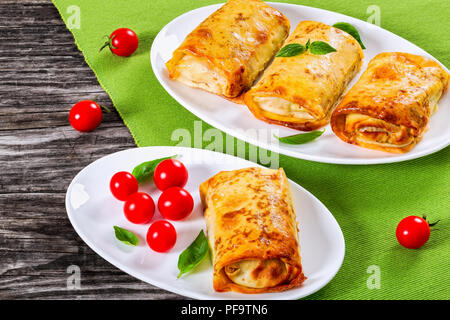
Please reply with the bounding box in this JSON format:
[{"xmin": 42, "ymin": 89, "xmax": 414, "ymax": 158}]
[{"xmin": 100, "ymin": 28, "xmax": 139, "ymax": 57}]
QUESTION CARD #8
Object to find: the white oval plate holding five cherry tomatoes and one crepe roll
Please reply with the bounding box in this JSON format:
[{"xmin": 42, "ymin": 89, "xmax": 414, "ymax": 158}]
[{"xmin": 66, "ymin": 147, "xmax": 345, "ymax": 299}]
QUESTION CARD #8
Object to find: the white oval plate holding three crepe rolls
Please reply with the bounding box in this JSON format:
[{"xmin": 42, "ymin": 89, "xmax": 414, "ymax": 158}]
[{"xmin": 150, "ymin": 2, "xmax": 450, "ymax": 164}]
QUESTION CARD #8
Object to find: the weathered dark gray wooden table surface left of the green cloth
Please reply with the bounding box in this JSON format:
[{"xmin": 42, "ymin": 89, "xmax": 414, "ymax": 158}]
[{"xmin": 0, "ymin": 0, "xmax": 182, "ymax": 300}]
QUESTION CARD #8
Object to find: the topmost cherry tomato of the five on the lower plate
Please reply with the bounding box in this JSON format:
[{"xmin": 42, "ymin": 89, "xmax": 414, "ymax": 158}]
[{"xmin": 153, "ymin": 159, "xmax": 188, "ymax": 191}]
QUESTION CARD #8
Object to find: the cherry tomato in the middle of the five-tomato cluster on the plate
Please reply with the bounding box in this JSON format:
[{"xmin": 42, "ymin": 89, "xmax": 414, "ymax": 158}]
[{"xmin": 123, "ymin": 192, "xmax": 155, "ymax": 224}]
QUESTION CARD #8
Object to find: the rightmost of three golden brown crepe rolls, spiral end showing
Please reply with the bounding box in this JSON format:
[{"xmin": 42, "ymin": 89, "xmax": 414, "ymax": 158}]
[{"xmin": 331, "ymin": 52, "xmax": 449, "ymax": 153}]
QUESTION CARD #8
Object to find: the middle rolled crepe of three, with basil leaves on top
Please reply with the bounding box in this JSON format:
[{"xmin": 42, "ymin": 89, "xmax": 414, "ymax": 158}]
[{"xmin": 244, "ymin": 21, "xmax": 363, "ymax": 131}]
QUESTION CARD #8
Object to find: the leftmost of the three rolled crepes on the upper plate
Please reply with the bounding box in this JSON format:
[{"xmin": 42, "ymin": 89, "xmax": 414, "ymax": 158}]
[{"xmin": 166, "ymin": 0, "xmax": 290, "ymax": 97}]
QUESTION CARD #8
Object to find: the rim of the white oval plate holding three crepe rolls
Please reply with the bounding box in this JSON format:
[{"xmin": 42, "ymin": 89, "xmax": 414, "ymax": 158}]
[{"xmin": 150, "ymin": 2, "xmax": 450, "ymax": 165}]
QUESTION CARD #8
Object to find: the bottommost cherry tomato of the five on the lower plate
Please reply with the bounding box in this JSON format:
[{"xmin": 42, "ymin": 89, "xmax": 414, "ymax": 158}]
[{"xmin": 147, "ymin": 220, "xmax": 177, "ymax": 252}]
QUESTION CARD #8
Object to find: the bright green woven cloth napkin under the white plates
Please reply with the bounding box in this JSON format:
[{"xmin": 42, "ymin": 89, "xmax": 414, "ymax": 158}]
[{"xmin": 53, "ymin": 0, "xmax": 450, "ymax": 299}]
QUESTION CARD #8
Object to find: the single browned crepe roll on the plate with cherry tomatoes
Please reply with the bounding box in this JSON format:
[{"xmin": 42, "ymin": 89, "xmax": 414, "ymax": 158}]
[{"xmin": 200, "ymin": 168, "xmax": 306, "ymax": 293}]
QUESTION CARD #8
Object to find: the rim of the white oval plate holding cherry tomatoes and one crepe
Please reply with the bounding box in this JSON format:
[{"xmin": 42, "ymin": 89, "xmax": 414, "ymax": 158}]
[{"xmin": 65, "ymin": 146, "xmax": 346, "ymax": 300}]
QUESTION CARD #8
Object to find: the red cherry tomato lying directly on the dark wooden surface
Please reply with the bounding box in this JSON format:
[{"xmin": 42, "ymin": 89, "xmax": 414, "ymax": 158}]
[{"xmin": 69, "ymin": 100, "xmax": 103, "ymax": 132}]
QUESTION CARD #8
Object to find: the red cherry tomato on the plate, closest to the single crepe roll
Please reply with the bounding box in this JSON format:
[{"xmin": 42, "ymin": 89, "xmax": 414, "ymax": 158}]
[{"xmin": 158, "ymin": 187, "xmax": 194, "ymax": 220}]
